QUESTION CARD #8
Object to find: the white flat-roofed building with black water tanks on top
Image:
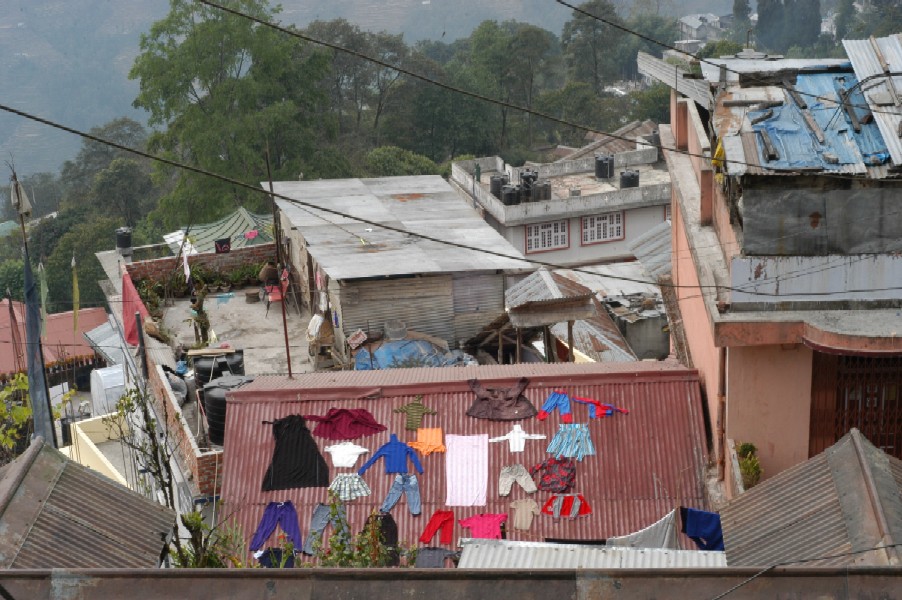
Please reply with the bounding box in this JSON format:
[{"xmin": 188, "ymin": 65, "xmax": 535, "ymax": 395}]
[{"xmin": 451, "ymin": 141, "xmax": 670, "ymax": 266}]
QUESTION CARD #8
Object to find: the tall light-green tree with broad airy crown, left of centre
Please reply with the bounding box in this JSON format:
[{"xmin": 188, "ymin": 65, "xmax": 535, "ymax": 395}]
[{"xmin": 129, "ymin": 0, "xmax": 328, "ymax": 227}]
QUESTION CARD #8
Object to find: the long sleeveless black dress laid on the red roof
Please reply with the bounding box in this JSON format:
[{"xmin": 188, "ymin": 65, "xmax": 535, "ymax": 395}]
[{"xmin": 263, "ymin": 415, "xmax": 329, "ymax": 492}]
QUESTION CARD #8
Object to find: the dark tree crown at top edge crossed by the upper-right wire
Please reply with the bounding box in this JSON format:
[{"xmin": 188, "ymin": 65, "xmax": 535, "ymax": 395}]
[{"xmin": 561, "ymin": 0, "xmax": 624, "ymax": 93}]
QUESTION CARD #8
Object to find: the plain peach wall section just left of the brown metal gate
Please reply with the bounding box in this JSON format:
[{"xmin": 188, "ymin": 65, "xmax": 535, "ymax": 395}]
[{"xmin": 726, "ymin": 344, "xmax": 813, "ymax": 478}]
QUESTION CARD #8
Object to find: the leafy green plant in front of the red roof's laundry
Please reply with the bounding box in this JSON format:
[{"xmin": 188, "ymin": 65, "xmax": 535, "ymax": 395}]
[{"xmin": 313, "ymin": 492, "xmax": 398, "ymax": 569}]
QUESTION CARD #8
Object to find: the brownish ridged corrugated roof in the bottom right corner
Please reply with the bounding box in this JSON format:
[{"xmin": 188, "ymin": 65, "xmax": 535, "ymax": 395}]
[{"xmin": 721, "ymin": 429, "xmax": 902, "ymax": 567}]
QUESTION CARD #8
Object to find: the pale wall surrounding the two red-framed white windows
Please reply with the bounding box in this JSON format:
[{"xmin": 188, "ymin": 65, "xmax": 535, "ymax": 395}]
[{"xmin": 502, "ymin": 205, "xmax": 665, "ymax": 265}]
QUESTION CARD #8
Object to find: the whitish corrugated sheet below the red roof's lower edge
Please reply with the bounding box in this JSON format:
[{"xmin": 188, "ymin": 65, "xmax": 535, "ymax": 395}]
[{"xmin": 457, "ymin": 539, "xmax": 727, "ymax": 569}]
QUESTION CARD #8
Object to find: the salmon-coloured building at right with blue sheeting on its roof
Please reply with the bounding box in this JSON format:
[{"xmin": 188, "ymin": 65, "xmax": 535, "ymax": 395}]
[{"xmin": 639, "ymin": 36, "xmax": 902, "ymax": 496}]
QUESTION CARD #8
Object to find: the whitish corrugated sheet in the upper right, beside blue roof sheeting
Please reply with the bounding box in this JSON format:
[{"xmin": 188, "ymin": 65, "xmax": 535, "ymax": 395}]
[{"xmin": 842, "ymin": 35, "xmax": 902, "ymax": 166}]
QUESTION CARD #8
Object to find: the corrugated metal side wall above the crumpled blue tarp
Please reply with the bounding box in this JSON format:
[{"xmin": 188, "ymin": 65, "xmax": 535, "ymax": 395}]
[{"xmin": 339, "ymin": 275, "xmax": 460, "ymax": 341}]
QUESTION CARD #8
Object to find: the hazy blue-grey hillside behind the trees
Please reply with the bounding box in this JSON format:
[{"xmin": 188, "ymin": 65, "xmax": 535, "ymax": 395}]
[{"xmin": 0, "ymin": 0, "xmax": 732, "ymax": 175}]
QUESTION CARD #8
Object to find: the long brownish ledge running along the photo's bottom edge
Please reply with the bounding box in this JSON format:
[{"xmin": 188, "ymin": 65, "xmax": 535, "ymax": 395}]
[{"xmin": 0, "ymin": 567, "xmax": 902, "ymax": 600}]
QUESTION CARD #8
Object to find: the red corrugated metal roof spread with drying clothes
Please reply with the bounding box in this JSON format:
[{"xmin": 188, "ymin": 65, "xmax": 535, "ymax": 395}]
[{"xmin": 222, "ymin": 363, "xmax": 707, "ymax": 564}]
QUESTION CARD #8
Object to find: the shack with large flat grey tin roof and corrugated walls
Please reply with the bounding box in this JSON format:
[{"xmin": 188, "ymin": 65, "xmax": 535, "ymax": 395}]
[{"xmin": 274, "ymin": 175, "xmax": 528, "ymax": 366}]
